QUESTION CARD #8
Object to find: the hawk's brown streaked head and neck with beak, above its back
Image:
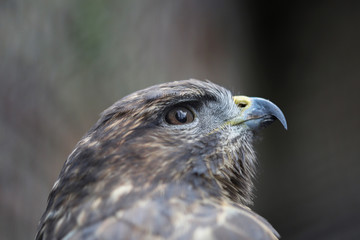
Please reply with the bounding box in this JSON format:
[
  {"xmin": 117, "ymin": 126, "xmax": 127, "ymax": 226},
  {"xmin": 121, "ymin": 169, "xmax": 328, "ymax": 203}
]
[{"xmin": 38, "ymin": 79, "xmax": 286, "ymax": 239}]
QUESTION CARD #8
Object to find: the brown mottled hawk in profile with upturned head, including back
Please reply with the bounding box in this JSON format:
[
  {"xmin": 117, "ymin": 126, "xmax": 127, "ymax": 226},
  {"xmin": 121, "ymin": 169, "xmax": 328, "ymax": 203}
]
[{"xmin": 36, "ymin": 79, "xmax": 287, "ymax": 240}]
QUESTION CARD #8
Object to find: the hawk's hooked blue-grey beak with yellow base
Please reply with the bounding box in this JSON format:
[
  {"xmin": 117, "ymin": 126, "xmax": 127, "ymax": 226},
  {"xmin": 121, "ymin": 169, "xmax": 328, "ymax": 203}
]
[{"xmin": 229, "ymin": 96, "xmax": 287, "ymax": 131}]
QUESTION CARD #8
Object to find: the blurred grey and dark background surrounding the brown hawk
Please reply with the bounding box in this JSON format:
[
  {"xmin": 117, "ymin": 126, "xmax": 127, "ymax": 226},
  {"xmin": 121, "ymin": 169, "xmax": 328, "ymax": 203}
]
[{"xmin": 0, "ymin": 0, "xmax": 360, "ymax": 240}]
